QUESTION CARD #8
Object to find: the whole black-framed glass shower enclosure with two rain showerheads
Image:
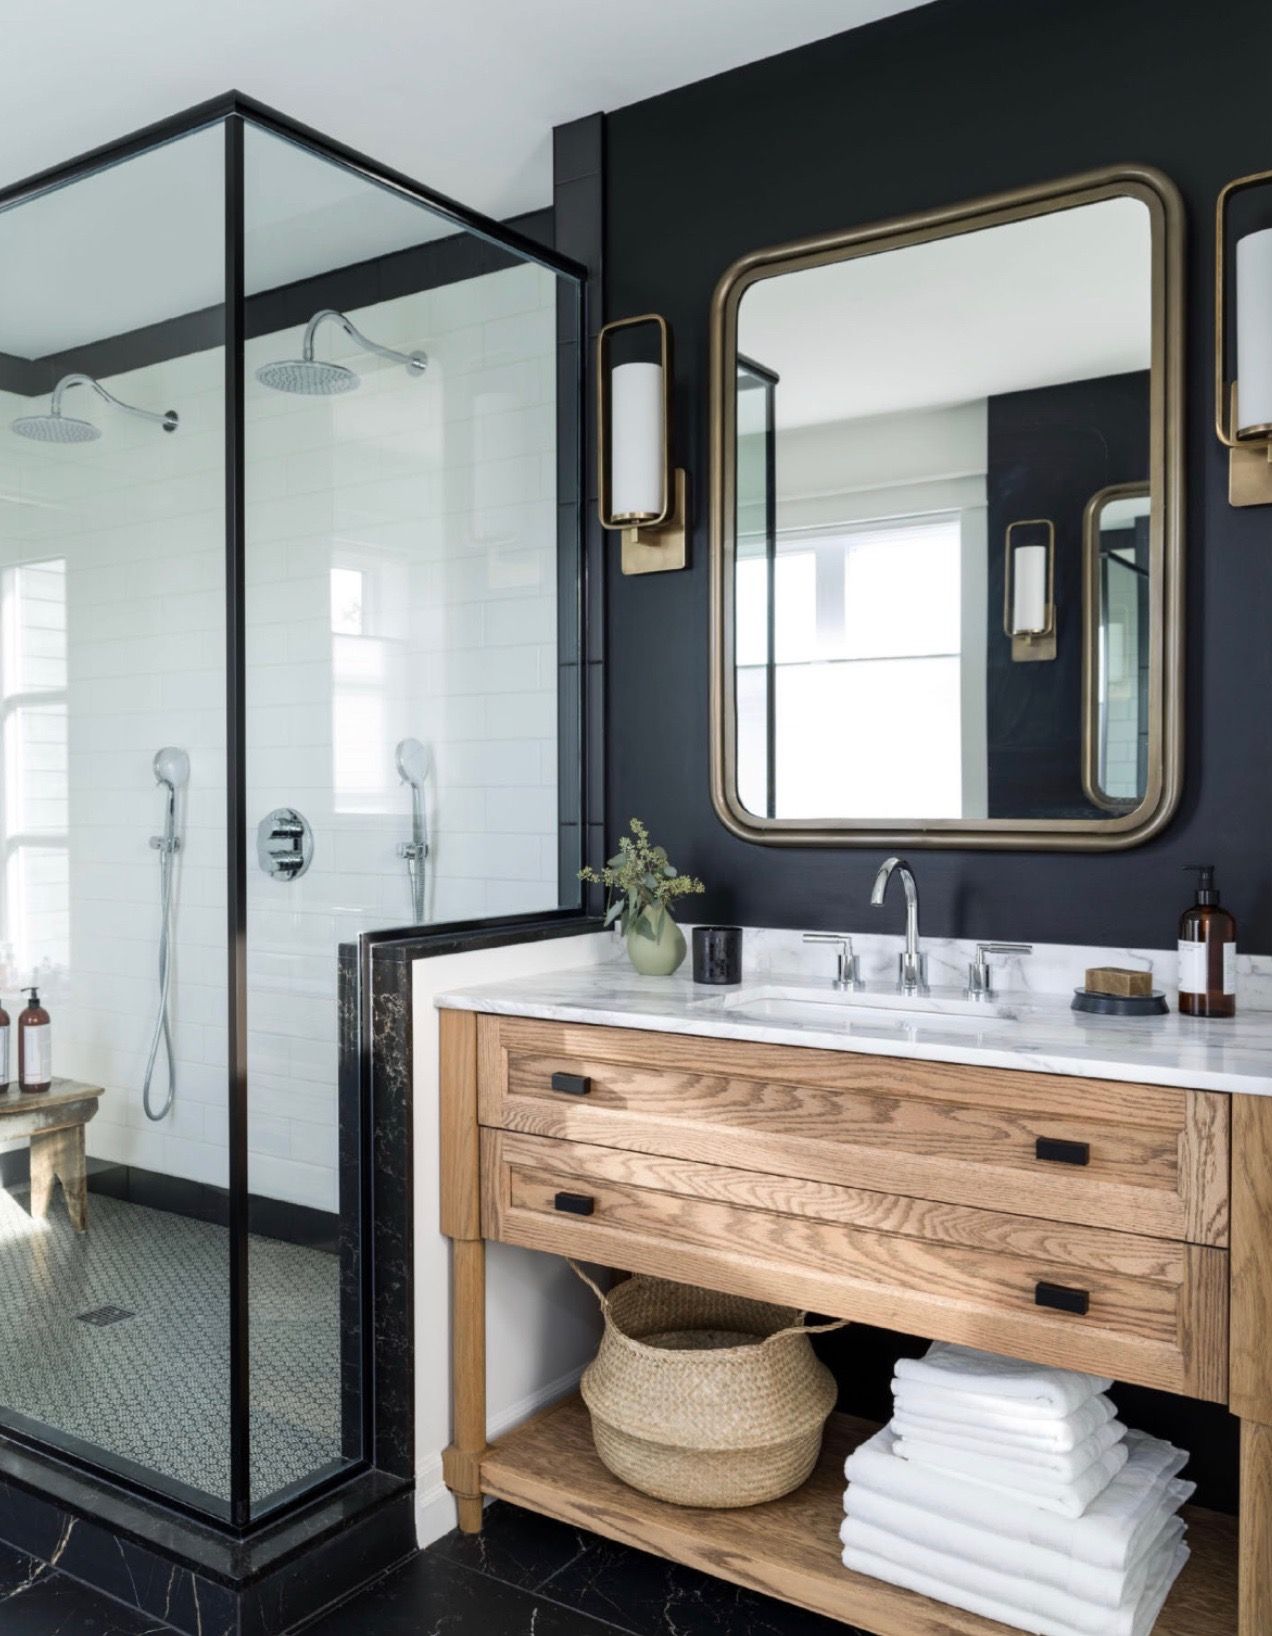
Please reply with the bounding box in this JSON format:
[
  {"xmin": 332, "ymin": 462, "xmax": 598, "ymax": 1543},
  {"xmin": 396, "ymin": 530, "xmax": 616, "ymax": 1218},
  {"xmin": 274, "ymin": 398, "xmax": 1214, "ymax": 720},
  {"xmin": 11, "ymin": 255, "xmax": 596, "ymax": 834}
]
[{"xmin": 0, "ymin": 95, "xmax": 582, "ymax": 1530}]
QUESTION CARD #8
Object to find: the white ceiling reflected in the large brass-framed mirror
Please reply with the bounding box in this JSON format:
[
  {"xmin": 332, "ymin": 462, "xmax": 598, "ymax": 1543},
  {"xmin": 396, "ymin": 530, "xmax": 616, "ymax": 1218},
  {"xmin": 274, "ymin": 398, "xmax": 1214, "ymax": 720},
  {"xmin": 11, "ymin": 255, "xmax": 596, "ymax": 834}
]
[{"xmin": 737, "ymin": 200, "xmax": 1151, "ymax": 427}]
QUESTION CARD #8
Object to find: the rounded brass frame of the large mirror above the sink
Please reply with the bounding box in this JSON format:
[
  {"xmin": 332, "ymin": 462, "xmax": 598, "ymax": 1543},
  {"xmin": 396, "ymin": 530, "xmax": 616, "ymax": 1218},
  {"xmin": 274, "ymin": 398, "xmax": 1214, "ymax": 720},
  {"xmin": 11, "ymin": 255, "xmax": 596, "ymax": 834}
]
[{"xmin": 710, "ymin": 165, "xmax": 1184, "ymax": 852}]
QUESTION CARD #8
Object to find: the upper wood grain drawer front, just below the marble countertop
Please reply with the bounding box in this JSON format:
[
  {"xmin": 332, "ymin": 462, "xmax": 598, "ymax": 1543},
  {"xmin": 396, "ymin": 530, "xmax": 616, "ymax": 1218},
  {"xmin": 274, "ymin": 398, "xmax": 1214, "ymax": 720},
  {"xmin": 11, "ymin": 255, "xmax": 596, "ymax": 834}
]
[{"xmin": 479, "ymin": 1016, "xmax": 1228, "ymax": 1245}]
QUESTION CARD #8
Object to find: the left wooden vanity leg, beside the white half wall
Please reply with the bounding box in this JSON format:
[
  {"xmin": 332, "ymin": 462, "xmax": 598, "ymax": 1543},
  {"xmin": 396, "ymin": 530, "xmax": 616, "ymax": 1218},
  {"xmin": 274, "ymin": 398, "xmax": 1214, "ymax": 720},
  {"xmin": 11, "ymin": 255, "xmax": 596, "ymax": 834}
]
[{"xmin": 440, "ymin": 1011, "xmax": 486, "ymax": 1533}]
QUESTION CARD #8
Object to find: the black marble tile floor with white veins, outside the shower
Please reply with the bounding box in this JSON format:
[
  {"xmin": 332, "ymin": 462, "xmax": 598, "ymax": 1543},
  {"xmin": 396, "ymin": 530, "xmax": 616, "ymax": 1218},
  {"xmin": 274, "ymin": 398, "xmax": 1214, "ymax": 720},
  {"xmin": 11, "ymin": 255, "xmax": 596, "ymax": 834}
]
[{"xmin": 0, "ymin": 1503, "xmax": 865, "ymax": 1636}]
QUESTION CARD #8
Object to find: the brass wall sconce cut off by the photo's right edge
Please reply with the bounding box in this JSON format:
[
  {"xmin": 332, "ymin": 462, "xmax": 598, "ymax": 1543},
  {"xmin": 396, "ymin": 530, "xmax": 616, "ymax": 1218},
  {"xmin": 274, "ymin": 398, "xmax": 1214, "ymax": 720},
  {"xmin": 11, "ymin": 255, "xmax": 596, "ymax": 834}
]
[{"xmin": 1215, "ymin": 170, "xmax": 1272, "ymax": 506}]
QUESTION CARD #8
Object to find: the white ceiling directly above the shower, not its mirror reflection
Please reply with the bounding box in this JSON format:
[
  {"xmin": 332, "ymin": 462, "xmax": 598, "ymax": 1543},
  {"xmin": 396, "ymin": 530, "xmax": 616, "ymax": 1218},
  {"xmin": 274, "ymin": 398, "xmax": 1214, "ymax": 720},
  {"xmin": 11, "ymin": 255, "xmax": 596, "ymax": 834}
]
[{"xmin": 0, "ymin": 0, "xmax": 920, "ymax": 218}]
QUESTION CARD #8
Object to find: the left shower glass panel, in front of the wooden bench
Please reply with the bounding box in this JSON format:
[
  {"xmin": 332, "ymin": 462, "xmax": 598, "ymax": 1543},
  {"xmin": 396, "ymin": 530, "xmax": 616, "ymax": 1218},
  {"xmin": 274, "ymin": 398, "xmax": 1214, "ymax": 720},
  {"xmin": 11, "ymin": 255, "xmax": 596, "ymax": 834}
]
[{"xmin": 0, "ymin": 126, "xmax": 231, "ymax": 1517}]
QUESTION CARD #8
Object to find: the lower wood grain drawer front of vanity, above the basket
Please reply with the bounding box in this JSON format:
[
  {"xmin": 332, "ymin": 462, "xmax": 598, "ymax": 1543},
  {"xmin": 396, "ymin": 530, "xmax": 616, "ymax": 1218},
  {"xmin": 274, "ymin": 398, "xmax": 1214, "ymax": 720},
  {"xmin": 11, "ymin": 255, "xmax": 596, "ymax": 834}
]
[{"xmin": 482, "ymin": 1130, "xmax": 1228, "ymax": 1402}]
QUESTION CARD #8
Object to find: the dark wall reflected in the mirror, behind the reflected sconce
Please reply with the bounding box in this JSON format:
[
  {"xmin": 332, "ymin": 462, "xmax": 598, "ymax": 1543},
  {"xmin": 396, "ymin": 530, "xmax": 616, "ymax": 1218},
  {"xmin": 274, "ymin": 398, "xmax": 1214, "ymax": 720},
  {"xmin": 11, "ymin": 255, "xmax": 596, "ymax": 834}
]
[{"xmin": 986, "ymin": 371, "xmax": 1149, "ymax": 818}]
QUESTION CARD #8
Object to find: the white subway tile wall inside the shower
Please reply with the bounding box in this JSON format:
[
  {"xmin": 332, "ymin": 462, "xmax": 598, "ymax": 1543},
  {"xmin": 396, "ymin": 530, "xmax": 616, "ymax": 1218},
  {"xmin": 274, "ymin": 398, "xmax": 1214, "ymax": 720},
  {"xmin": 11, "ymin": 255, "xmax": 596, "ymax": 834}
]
[{"xmin": 0, "ymin": 267, "xmax": 572, "ymax": 1211}]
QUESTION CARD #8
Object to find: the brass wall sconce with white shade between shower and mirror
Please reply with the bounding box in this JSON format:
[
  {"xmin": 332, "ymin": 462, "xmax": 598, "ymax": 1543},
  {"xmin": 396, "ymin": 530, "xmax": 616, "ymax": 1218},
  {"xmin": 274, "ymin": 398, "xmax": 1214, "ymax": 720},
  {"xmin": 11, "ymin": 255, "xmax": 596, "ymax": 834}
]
[{"xmin": 597, "ymin": 312, "xmax": 687, "ymax": 574}]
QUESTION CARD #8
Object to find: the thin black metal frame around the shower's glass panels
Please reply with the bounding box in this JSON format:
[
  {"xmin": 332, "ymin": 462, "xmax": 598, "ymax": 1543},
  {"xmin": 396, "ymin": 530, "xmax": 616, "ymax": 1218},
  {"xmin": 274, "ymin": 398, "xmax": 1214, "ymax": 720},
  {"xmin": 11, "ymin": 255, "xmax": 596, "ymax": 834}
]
[{"xmin": 0, "ymin": 92, "xmax": 595, "ymax": 1536}]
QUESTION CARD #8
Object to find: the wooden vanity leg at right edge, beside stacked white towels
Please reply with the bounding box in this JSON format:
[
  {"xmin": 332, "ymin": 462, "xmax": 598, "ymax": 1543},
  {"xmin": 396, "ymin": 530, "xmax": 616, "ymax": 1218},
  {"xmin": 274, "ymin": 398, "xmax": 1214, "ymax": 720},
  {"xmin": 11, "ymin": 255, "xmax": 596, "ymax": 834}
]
[{"xmin": 1228, "ymin": 1096, "xmax": 1272, "ymax": 1636}]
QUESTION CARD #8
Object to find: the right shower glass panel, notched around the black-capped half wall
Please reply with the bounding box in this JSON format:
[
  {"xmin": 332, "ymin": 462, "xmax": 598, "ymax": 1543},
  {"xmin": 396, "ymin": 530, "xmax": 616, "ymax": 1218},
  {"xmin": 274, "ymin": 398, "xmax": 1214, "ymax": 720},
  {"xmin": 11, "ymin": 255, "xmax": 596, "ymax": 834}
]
[{"xmin": 244, "ymin": 126, "xmax": 579, "ymax": 1512}]
